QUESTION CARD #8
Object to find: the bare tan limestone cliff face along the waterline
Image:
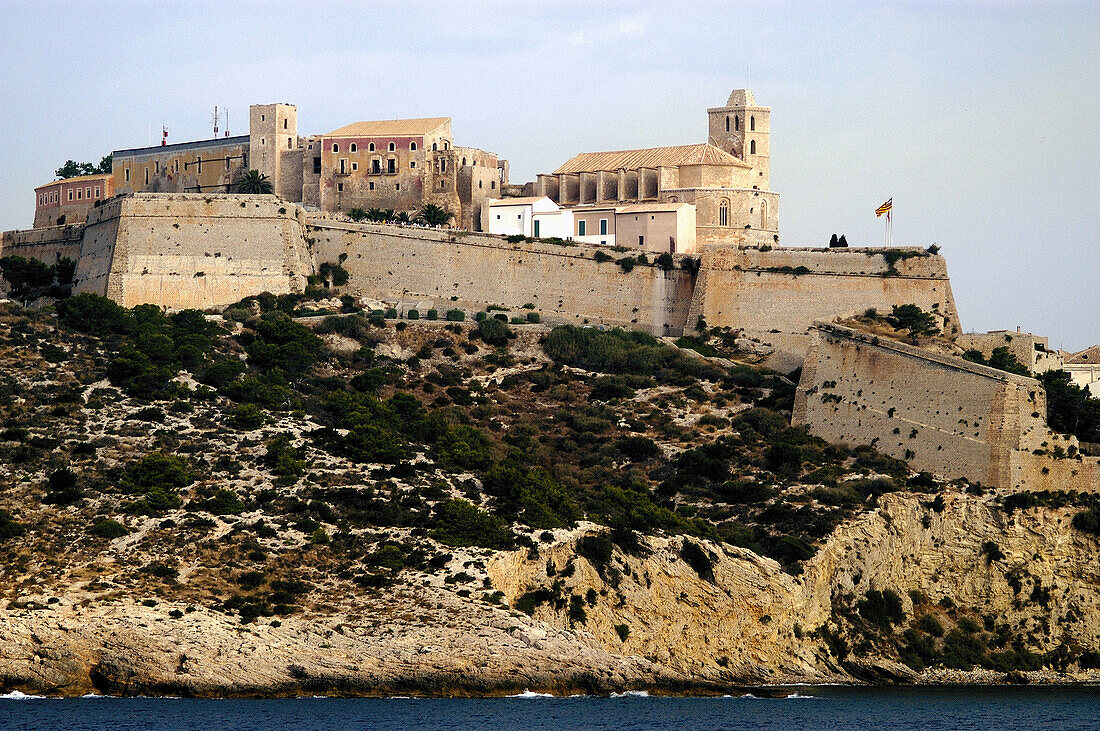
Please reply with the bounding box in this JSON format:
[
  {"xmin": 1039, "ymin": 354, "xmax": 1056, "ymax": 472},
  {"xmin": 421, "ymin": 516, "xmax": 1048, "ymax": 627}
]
[{"xmin": 0, "ymin": 494, "xmax": 1100, "ymax": 696}]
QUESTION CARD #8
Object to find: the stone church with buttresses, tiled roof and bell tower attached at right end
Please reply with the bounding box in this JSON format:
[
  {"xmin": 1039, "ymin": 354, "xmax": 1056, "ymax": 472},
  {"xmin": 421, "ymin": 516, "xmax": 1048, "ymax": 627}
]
[{"xmin": 535, "ymin": 89, "xmax": 779, "ymax": 246}]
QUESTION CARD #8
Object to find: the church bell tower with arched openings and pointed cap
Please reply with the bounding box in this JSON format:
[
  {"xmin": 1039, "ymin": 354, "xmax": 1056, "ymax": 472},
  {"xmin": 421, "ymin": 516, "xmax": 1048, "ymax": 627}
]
[{"xmin": 706, "ymin": 89, "xmax": 771, "ymax": 190}]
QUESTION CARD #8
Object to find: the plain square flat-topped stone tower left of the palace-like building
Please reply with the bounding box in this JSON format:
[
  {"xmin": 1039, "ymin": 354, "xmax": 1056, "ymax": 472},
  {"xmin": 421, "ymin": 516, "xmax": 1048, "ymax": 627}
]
[{"xmin": 249, "ymin": 104, "xmax": 301, "ymax": 202}]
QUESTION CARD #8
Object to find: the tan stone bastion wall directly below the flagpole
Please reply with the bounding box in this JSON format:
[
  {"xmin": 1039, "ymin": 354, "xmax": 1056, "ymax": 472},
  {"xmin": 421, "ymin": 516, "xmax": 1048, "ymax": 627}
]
[{"xmin": 689, "ymin": 246, "xmax": 959, "ymax": 354}]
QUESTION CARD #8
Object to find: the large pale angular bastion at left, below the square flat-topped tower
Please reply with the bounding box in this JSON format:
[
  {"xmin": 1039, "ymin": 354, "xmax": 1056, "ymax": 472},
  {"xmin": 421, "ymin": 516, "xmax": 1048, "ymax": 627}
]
[{"xmin": 74, "ymin": 193, "xmax": 312, "ymax": 309}]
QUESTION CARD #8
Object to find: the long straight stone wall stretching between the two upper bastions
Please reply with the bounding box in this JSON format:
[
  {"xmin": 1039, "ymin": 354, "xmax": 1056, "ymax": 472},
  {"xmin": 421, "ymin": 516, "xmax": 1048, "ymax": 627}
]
[{"xmin": 308, "ymin": 219, "xmax": 693, "ymax": 335}]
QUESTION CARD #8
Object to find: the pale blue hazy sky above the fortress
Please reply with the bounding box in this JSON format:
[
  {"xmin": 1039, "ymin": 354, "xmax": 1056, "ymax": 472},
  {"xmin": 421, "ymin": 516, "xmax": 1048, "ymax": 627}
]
[{"xmin": 0, "ymin": 0, "xmax": 1100, "ymax": 350}]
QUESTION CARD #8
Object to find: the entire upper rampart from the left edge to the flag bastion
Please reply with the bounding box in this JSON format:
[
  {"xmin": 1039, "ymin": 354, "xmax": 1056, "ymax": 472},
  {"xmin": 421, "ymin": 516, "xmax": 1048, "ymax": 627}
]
[{"xmin": 3, "ymin": 193, "xmax": 958, "ymax": 358}]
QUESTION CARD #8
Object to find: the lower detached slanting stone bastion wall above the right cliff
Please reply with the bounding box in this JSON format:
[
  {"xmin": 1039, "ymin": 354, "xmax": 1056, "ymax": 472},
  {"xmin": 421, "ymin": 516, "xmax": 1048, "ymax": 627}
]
[{"xmin": 792, "ymin": 322, "xmax": 1100, "ymax": 490}]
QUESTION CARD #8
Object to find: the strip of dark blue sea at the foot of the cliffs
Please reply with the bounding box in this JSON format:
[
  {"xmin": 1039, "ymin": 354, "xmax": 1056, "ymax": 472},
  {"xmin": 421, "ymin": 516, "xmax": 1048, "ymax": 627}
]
[{"xmin": 0, "ymin": 687, "xmax": 1100, "ymax": 731}]
